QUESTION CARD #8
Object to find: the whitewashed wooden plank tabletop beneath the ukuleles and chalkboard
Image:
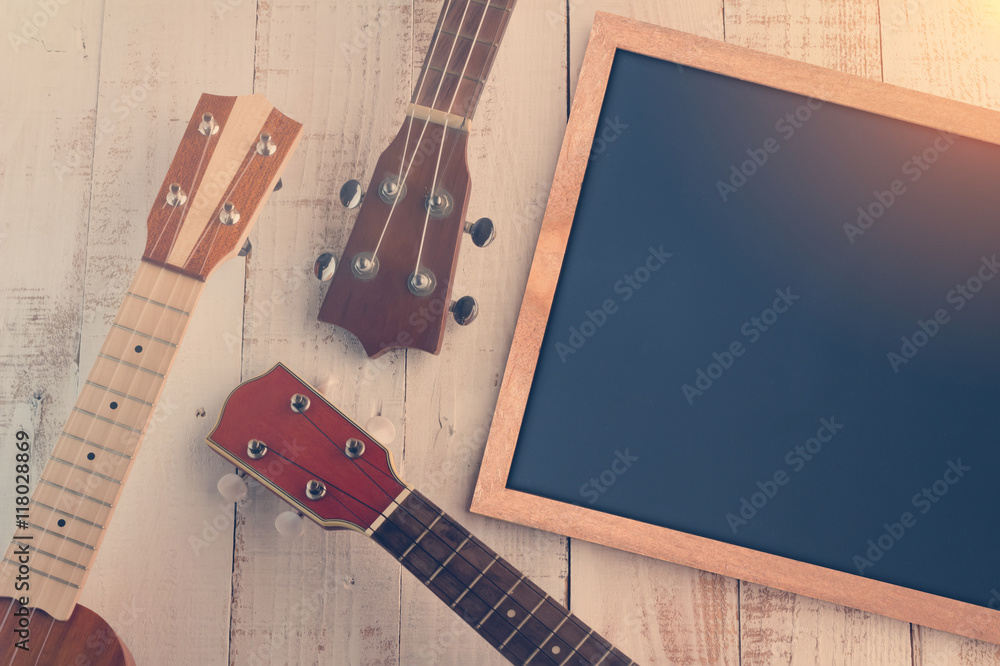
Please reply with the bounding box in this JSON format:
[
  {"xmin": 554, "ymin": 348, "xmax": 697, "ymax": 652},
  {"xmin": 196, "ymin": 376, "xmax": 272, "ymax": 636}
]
[{"xmin": 0, "ymin": 0, "xmax": 1000, "ymax": 666}]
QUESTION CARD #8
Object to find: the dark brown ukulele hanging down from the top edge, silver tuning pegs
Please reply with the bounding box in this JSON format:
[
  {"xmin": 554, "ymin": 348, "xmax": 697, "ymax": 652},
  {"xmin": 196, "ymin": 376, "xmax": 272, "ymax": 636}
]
[{"xmin": 315, "ymin": 0, "xmax": 515, "ymax": 358}]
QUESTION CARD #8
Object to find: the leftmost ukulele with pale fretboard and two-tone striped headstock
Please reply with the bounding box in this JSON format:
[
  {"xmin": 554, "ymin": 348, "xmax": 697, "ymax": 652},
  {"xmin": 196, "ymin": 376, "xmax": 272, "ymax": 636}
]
[{"xmin": 0, "ymin": 95, "xmax": 302, "ymax": 666}]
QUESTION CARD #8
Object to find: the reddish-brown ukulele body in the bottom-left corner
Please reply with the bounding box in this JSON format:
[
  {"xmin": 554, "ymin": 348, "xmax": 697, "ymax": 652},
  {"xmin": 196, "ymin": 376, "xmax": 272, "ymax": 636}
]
[{"xmin": 0, "ymin": 597, "xmax": 135, "ymax": 666}]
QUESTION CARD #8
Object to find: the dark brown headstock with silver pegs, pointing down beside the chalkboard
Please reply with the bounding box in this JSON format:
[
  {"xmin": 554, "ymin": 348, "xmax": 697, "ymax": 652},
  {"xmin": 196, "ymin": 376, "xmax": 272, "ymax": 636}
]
[{"xmin": 319, "ymin": 110, "xmax": 493, "ymax": 358}]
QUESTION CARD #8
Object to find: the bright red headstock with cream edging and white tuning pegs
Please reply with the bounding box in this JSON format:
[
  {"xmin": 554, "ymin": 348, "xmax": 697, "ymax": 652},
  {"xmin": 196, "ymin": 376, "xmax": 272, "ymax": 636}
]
[{"xmin": 207, "ymin": 363, "xmax": 406, "ymax": 533}]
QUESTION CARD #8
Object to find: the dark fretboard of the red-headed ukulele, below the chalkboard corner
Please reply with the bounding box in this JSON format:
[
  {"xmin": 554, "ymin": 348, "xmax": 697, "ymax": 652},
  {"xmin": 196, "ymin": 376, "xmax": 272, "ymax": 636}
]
[{"xmin": 372, "ymin": 492, "xmax": 631, "ymax": 666}]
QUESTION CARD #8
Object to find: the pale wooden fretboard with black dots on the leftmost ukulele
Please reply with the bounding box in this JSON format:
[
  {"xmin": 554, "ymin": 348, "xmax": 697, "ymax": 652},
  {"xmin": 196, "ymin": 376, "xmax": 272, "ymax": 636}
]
[{"xmin": 0, "ymin": 261, "xmax": 205, "ymax": 619}]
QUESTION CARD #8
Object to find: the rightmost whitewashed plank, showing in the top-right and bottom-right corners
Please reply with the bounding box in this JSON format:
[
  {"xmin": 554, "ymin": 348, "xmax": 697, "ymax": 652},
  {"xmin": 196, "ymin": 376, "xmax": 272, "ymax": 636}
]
[{"xmin": 880, "ymin": 0, "xmax": 1000, "ymax": 666}]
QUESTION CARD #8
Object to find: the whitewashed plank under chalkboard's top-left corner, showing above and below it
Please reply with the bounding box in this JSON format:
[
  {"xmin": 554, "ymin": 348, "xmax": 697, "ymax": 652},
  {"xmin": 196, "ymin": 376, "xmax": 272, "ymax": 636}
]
[{"xmin": 569, "ymin": 0, "xmax": 740, "ymax": 664}]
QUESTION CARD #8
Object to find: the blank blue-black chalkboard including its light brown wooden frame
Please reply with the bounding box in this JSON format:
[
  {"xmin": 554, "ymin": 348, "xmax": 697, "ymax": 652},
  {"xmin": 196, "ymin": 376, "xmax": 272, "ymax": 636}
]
[{"xmin": 472, "ymin": 14, "xmax": 1000, "ymax": 642}]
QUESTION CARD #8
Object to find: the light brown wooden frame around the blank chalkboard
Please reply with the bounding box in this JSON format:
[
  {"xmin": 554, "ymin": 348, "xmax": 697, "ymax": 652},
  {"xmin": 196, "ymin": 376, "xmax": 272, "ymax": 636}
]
[{"xmin": 471, "ymin": 12, "xmax": 1000, "ymax": 643}]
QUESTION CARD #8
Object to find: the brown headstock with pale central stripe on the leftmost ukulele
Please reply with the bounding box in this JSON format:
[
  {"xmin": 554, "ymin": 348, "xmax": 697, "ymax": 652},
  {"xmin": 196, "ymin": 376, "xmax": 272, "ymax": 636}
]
[{"xmin": 143, "ymin": 94, "xmax": 302, "ymax": 280}]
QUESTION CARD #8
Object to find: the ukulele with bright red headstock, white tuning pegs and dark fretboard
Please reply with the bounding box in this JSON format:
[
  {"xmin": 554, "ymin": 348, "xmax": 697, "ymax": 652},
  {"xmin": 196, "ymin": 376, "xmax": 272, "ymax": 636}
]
[{"xmin": 207, "ymin": 363, "xmax": 635, "ymax": 666}]
